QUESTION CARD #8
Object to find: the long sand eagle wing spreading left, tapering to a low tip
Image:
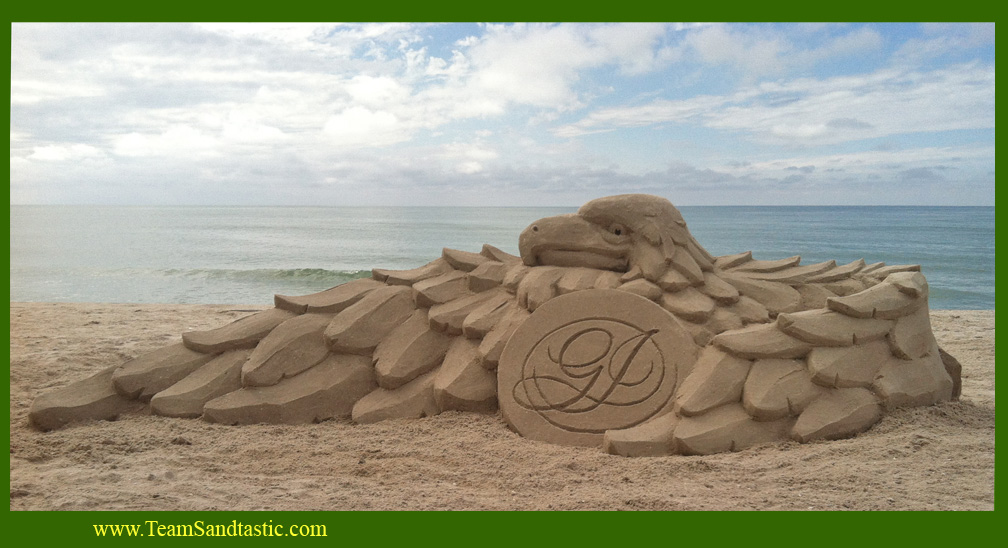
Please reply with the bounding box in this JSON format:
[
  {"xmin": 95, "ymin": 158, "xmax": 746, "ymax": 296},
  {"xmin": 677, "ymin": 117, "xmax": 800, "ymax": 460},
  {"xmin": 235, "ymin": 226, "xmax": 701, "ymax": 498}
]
[{"xmin": 29, "ymin": 246, "xmax": 540, "ymax": 430}]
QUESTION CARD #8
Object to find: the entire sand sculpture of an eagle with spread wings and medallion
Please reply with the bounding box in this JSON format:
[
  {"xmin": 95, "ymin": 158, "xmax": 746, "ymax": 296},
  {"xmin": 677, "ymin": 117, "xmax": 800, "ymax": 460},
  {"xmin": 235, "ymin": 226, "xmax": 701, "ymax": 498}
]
[{"xmin": 29, "ymin": 194, "xmax": 960, "ymax": 455}]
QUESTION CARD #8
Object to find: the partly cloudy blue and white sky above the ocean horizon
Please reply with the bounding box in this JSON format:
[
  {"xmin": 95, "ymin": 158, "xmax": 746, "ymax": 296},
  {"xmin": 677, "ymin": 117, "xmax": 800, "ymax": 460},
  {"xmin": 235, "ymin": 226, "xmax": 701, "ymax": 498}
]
[{"xmin": 10, "ymin": 23, "xmax": 995, "ymax": 206}]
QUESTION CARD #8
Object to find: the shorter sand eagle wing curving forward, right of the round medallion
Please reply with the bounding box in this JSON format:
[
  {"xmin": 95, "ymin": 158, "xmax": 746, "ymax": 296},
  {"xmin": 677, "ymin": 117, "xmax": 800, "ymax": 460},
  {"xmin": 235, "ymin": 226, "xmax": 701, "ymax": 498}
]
[{"xmin": 605, "ymin": 259, "xmax": 960, "ymax": 455}]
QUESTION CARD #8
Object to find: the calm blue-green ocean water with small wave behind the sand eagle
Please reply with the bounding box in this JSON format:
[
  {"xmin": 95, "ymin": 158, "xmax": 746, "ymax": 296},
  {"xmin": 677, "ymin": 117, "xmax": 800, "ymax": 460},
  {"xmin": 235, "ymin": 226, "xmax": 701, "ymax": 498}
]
[{"xmin": 10, "ymin": 206, "xmax": 995, "ymax": 309}]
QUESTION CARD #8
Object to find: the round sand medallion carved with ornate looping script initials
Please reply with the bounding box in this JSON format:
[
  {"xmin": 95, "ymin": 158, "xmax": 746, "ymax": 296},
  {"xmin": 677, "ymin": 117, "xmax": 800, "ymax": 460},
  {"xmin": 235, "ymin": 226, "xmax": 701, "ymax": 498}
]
[{"xmin": 497, "ymin": 289, "xmax": 699, "ymax": 446}]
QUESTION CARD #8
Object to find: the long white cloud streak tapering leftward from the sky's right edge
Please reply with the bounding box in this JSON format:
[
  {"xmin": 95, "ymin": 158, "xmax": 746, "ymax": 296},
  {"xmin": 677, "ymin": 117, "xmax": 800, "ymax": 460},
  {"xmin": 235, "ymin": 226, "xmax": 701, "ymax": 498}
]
[{"xmin": 554, "ymin": 63, "xmax": 994, "ymax": 145}]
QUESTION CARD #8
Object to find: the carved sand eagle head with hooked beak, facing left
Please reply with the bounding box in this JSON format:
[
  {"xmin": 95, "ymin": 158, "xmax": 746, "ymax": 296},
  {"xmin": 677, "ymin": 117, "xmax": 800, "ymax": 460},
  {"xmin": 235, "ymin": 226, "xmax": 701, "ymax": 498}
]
[{"xmin": 518, "ymin": 194, "xmax": 712, "ymax": 283}]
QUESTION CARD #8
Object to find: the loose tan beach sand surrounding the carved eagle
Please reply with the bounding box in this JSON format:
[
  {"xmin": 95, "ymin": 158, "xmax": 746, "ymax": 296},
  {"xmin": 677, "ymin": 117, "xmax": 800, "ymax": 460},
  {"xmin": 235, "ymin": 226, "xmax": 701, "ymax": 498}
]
[{"xmin": 10, "ymin": 303, "xmax": 995, "ymax": 510}]
